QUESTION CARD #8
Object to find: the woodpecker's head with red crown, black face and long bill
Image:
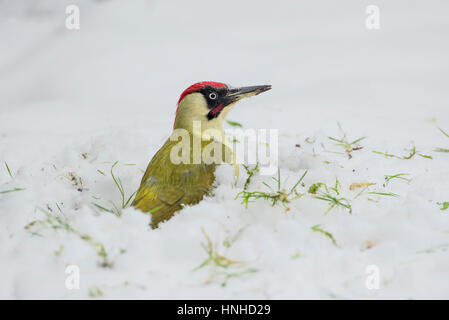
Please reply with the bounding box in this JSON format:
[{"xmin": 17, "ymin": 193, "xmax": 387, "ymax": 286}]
[{"xmin": 174, "ymin": 81, "xmax": 271, "ymax": 130}]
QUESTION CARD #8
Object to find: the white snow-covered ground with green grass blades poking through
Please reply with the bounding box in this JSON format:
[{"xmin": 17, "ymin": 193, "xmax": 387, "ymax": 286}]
[{"xmin": 0, "ymin": 0, "xmax": 449, "ymax": 299}]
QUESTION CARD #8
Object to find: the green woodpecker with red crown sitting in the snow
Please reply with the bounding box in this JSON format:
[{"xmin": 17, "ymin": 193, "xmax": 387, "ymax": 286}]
[{"xmin": 132, "ymin": 81, "xmax": 271, "ymax": 228}]
